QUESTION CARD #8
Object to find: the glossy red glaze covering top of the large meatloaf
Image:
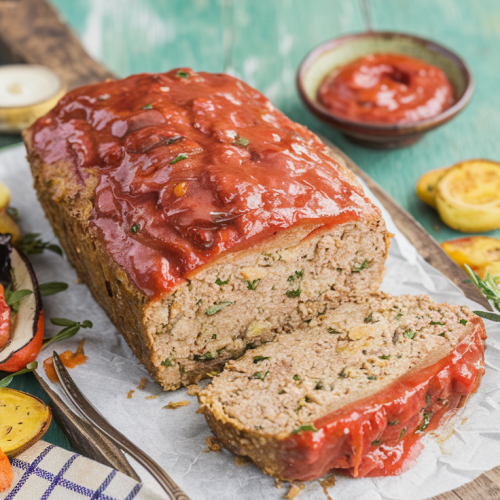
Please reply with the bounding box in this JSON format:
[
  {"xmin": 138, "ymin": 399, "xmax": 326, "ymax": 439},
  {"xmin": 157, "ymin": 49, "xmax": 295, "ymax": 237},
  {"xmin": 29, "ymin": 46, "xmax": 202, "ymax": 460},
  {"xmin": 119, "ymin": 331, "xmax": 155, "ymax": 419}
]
[{"xmin": 32, "ymin": 69, "xmax": 377, "ymax": 298}]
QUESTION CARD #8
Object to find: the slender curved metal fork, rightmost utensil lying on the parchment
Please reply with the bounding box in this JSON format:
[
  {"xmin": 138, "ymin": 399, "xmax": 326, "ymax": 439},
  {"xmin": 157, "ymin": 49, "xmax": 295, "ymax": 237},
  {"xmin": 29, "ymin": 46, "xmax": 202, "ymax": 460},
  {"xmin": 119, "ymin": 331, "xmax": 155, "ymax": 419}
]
[{"xmin": 52, "ymin": 352, "xmax": 190, "ymax": 500}]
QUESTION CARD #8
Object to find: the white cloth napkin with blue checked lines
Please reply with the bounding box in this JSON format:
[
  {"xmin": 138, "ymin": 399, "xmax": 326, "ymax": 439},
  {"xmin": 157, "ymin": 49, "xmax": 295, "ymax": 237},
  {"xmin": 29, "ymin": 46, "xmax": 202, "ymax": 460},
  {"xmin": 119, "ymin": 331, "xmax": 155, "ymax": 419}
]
[{"xmin": 0, "ymin": 441, "xmax": 164, "ymax": 500}]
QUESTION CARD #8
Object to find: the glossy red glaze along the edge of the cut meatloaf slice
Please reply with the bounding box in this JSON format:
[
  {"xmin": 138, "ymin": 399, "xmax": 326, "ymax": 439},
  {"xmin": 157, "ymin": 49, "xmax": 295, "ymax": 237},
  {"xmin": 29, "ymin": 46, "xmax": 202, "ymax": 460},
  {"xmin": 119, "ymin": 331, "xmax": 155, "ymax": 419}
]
[{"xmin": 281, "ymin": 318, "xmax": 486, "ymax": 481}]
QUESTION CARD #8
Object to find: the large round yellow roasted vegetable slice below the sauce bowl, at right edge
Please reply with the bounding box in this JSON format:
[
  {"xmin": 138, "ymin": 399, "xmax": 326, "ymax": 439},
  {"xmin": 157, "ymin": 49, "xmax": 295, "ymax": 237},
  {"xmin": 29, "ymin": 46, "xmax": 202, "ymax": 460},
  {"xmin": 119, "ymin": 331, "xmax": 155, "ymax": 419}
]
[{"xmin": 435, "ymin": 160, "xmax": 500, "ymax": 233}]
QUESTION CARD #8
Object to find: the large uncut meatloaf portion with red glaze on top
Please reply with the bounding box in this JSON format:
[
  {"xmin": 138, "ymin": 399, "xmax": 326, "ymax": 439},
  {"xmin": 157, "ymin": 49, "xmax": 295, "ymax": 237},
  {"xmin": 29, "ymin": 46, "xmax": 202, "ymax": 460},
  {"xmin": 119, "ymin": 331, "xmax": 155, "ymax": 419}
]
[{"xmin": 23, "ymin": 69, "xmax": 389, "ymax": 390}]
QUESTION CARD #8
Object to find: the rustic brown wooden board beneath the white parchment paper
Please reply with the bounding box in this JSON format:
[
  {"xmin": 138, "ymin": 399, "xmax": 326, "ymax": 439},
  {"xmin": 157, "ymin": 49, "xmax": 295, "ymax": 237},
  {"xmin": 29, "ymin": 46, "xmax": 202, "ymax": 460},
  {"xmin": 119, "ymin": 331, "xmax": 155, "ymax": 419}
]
[{"xmin": 0, "ymin": 0, "xmax": 500, "ymax": 500}]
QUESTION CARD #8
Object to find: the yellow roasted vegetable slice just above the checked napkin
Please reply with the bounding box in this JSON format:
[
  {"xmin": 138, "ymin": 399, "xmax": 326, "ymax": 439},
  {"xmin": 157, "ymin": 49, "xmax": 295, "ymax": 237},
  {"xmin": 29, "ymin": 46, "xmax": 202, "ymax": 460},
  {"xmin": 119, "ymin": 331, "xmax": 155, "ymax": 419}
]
[{"xmin": 0, "ymin": 387, "xmax": 52, "ymax": 458}]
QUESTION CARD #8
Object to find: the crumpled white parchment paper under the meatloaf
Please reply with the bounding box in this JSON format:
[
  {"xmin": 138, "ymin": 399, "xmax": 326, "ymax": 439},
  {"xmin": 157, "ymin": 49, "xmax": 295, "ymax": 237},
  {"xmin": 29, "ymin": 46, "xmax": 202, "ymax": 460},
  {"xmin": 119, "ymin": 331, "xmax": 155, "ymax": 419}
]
[{"xmin": 0, "ymin": 146, "xmax": 500, "ymax": 500}]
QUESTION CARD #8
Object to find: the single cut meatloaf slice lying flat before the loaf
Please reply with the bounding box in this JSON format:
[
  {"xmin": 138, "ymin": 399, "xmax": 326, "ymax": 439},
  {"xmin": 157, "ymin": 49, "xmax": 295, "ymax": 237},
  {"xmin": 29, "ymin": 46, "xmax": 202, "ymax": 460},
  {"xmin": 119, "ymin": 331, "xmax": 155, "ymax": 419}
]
[{"xmin": 199, "ymin": 294, "xmax": 486, "ymax": 480}]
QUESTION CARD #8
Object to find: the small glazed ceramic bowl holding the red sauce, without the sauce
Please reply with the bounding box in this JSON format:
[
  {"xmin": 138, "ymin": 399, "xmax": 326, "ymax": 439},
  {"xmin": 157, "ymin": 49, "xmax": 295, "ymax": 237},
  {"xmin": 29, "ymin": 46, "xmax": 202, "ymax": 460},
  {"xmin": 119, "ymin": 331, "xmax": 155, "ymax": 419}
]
[{"xmin": 297, "ymin": 31, "xmax": 474, "ymax": 149}]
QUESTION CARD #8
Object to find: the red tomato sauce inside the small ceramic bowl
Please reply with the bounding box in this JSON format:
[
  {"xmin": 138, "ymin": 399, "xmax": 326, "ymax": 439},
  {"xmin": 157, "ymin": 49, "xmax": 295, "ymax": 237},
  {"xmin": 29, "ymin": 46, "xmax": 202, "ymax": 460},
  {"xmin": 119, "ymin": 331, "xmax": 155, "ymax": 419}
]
[{"xmin": 318, "ymin": 54, "xmax": 454, "ymax": 123}]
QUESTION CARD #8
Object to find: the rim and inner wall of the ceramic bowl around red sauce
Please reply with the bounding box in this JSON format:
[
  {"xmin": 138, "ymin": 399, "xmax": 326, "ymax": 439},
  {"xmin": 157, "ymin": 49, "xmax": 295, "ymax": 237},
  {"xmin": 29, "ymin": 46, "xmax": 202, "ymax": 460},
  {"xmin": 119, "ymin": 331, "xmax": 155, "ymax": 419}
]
[{"xmin": 297, "ymin": 31, "xmax": 474, "ymax": 132}]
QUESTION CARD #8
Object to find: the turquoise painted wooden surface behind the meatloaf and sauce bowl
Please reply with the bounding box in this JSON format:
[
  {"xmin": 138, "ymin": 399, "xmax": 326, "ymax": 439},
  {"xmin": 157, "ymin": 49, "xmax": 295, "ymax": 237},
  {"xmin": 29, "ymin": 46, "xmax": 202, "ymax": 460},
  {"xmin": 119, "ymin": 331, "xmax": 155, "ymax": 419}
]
[{"xmin": 0, "ymin": 0, "xmax": 500, "ymax": 452}]
